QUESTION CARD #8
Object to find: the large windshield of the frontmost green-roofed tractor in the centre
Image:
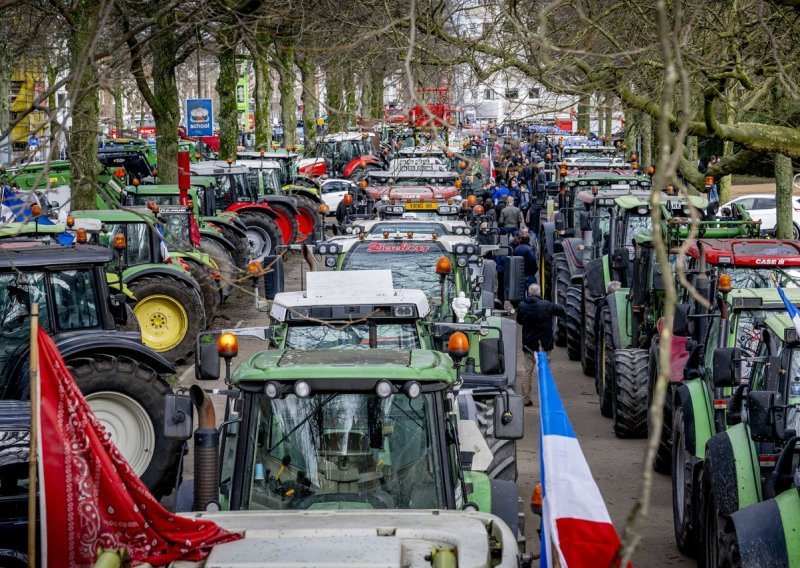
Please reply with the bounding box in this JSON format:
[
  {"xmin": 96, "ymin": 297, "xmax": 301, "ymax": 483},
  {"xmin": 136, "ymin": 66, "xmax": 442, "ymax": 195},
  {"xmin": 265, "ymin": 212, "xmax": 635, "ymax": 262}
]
[{"xmin": 241, "ymin": 392, "xmax": 446, "ymax": 509}]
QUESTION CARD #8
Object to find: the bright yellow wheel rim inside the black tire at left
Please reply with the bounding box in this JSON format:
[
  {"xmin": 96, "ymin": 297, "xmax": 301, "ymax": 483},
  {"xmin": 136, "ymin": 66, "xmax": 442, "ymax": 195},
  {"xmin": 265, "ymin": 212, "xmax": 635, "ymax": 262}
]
[{"xmin": 133, "ymin": 294, "xmax": 189, "ymax": 353}]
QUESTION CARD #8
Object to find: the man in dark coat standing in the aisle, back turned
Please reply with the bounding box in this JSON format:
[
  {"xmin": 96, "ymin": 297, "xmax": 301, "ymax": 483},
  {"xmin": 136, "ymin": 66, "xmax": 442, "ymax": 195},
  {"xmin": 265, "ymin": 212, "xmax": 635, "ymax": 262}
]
[{"xmin": 517, "ymin": 284, "xmax": 566, "ymax": 406}]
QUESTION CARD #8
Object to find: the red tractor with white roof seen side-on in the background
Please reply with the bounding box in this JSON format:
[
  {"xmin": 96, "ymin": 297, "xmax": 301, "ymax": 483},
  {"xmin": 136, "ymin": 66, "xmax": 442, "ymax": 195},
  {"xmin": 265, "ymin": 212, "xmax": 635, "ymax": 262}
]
[{"xmin": 297, "ymin": 132, "xmax": 385, "ymax": 181}]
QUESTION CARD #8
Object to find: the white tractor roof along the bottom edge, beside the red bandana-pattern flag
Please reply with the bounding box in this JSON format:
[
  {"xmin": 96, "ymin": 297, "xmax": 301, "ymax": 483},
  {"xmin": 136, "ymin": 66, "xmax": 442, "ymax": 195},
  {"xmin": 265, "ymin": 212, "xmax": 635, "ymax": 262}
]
[{"xmin": 172, "ymin": 510, "xmax": 519, "ymax": 568}]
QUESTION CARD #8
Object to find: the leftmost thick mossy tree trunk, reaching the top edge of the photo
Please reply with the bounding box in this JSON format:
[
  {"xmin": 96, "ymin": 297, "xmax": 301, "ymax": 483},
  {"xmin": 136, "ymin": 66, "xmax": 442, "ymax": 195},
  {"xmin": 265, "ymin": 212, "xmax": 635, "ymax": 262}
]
[{"xmin": 67, "ymin": 7, "xmax": 100, "ymax": 209}]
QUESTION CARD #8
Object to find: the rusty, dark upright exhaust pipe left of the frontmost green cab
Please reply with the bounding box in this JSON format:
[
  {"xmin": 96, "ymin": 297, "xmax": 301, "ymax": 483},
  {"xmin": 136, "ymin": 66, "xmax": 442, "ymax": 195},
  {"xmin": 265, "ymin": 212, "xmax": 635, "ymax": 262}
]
[{"xmin": 189, "ymin": 385, "xmax": 219, "ymax": 511}]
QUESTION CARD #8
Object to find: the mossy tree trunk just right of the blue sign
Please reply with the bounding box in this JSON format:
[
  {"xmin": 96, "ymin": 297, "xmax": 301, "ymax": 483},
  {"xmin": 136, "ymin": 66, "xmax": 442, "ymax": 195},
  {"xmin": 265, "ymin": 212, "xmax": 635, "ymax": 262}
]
[{"xmin": 217, "ymin": 36, "xmax": 239, "ymax": 160}]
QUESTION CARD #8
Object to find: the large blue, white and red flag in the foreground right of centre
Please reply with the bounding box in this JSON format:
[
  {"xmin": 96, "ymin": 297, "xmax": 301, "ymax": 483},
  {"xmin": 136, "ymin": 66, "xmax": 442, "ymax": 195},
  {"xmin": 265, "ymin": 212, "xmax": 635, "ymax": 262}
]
[{"xmin": 537, "ymin": 351, "xmax": 620, "ymax": 568}]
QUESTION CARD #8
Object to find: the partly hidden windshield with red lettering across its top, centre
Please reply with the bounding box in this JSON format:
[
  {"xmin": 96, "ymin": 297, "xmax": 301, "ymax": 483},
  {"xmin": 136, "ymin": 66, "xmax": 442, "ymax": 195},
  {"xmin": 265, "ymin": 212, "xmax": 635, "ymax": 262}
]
[{"xmin": 342, "ymin": 241, "xmax": 455, "ymax": 298}]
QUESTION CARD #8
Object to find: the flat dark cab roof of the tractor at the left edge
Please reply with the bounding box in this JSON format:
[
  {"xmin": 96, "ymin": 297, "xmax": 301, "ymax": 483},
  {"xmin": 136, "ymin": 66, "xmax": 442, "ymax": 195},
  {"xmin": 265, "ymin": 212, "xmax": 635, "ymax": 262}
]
[{"xmin": 0, "ymin": 240, "xmax": 114, "ymax": 270}]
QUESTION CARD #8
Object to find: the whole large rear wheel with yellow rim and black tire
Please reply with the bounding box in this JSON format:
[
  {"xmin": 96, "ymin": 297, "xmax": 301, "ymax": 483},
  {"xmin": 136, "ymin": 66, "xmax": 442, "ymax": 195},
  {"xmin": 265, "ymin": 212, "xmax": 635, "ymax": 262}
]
[{"xmin": 128, "ymin": 276, "xmax": 206, "ymax": 363}]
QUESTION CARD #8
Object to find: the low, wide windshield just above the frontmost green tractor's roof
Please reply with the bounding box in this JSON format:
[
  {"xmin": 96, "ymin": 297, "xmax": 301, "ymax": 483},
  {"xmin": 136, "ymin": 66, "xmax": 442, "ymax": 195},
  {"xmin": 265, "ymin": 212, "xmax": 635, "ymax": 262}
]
[{"xmin": 286, "ymin": 322, "xmax": 420, "ymax": 349}]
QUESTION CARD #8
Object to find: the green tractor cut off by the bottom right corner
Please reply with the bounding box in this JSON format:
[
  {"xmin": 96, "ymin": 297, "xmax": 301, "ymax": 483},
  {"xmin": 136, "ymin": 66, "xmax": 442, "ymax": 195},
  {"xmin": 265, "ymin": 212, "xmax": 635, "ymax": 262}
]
[{"xmin": 698, "ymin": 313, "xmax": 800, "ymax": 566}]
